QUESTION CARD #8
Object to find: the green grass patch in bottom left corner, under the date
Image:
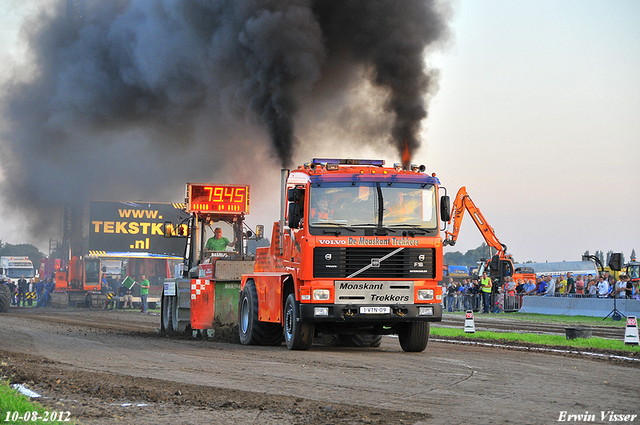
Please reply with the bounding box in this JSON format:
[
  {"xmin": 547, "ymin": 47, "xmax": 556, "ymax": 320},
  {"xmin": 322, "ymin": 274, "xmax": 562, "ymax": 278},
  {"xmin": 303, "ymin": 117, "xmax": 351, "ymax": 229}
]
[{"xmin": 0, "ymin": 380, "xmax": 74, "ymax": 425}]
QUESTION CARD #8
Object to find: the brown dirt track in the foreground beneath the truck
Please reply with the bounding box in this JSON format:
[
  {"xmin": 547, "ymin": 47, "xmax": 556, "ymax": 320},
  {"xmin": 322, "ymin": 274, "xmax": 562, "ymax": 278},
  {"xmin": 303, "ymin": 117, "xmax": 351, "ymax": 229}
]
[{"xmin": 0, "ymin": 308, "xmax": 640, "ymax": 424}]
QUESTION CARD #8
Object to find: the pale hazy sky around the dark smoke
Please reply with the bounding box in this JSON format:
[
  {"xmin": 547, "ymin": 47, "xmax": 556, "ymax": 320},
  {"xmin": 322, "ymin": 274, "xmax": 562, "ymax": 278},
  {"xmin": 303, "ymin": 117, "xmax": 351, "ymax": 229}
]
[{"xmin": 0, "ymin": 0, "xmax": 640, "ymax": 262}]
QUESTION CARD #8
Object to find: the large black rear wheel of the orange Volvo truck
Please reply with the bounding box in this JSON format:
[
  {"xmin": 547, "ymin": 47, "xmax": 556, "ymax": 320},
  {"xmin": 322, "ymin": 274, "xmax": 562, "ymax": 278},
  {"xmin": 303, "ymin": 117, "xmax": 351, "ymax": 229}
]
[{"xmin": 238, "ymin": 280, "xmax": 282, "ymax": 345}]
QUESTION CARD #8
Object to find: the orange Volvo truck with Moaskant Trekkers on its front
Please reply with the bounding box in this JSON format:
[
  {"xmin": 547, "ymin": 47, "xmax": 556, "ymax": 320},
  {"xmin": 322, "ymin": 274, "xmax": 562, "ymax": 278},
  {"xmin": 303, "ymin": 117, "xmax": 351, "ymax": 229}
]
[{"xmin": 238, "ymin": 159, "xmax": 450, "ymax": 352}]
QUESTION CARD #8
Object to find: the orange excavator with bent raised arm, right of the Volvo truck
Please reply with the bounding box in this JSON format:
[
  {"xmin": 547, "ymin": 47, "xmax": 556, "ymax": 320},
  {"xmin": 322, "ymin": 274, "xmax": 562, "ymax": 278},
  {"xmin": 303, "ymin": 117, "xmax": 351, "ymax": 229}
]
[{"xmin": 443, "ymin": 186, "xmax": 536, "ymax": 291}]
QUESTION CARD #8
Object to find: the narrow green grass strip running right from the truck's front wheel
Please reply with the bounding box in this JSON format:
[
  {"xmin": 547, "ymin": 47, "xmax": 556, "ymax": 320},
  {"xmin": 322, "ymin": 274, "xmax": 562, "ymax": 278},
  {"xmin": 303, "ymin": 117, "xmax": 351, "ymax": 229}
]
[{"xmin": 431, "ymin": 326, "xmax": 640, "ymax": 353}]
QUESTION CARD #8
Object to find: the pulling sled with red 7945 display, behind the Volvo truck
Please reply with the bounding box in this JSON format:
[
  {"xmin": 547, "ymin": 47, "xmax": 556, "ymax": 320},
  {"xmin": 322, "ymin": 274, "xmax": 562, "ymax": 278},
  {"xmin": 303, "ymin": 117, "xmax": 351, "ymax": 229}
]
[{"xmin": 161, "ymin": 183, "xmax": 262, "ymax": 336}]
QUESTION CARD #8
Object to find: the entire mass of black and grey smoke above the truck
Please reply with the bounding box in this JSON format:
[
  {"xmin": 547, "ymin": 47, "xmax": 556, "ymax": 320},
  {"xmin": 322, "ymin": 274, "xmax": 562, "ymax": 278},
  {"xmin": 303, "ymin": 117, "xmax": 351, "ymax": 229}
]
[{"xmin": 0, "ymin": 0, "xmax": 448, "ymax": 238}]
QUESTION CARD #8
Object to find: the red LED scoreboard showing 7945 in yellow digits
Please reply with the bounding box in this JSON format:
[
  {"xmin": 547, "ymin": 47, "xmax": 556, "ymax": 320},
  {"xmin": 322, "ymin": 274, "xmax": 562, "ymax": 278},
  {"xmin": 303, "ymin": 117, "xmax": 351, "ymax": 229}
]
[{"xmin": 187, "ymin": 183, "xmax": 249, "ymax": 214}]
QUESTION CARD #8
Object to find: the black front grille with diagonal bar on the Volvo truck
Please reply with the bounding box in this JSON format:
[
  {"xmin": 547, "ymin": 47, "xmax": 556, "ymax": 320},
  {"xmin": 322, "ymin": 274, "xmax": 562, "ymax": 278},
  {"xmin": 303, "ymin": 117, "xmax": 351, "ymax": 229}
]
[{"xmin": 313, "ymin": 247, "xmax": 436, "ymax": 279}]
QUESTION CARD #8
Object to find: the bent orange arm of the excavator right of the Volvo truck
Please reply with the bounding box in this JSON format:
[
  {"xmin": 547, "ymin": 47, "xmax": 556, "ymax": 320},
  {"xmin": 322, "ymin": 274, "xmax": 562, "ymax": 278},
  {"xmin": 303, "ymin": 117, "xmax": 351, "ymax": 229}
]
[{"xmin": 443, "ymin": 186, "xmax": 507, "ymax": 258}]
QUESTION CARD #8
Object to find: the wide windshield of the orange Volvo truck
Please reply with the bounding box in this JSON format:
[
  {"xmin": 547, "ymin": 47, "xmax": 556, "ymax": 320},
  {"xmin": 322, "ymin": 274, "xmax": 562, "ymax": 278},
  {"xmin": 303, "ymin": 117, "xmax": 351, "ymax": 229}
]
[{"xmin": 309, "ymin": 182, "xmax": 438, "ymax": 229}]
